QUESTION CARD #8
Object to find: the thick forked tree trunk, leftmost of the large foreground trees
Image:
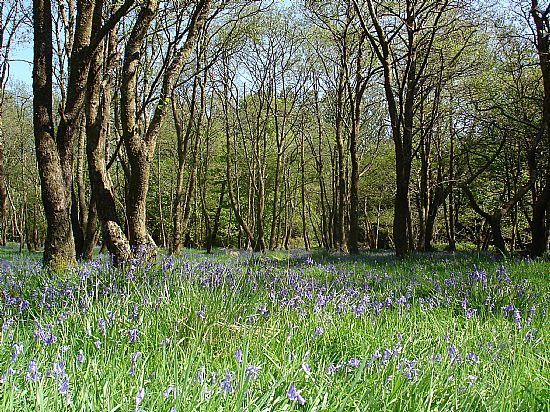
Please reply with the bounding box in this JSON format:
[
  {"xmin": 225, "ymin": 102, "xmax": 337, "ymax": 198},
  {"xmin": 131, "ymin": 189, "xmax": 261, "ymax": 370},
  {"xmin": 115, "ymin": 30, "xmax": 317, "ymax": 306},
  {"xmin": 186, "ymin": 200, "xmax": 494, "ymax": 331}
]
[{"xmin": 33, "ymin": 0, "xmax": 133, "ymax": 266}]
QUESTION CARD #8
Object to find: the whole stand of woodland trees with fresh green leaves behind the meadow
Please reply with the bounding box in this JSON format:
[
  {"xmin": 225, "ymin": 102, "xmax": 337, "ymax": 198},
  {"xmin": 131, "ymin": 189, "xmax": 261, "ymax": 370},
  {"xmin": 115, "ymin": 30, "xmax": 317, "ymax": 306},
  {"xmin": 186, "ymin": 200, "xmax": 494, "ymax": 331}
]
[{"xmin": 0, "ymin": 0, "xmax": 550, "ymax": 264}]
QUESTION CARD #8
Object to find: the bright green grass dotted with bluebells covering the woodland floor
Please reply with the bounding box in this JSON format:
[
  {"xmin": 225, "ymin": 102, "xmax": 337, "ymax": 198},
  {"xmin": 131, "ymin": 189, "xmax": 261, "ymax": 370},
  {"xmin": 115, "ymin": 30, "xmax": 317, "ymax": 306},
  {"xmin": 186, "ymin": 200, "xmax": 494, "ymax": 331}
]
[{"xmin": 0, "ymin": 246, "xmax": 550, "ymax": 411}]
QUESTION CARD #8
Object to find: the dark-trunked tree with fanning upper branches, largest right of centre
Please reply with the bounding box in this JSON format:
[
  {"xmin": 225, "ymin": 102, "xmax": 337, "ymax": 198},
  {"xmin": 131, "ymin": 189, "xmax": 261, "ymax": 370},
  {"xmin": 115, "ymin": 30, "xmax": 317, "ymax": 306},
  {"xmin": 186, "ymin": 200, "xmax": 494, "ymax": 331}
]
[{"xmin": 352, "ymin": 0, "xmax": 451, "ymax": 256}]
